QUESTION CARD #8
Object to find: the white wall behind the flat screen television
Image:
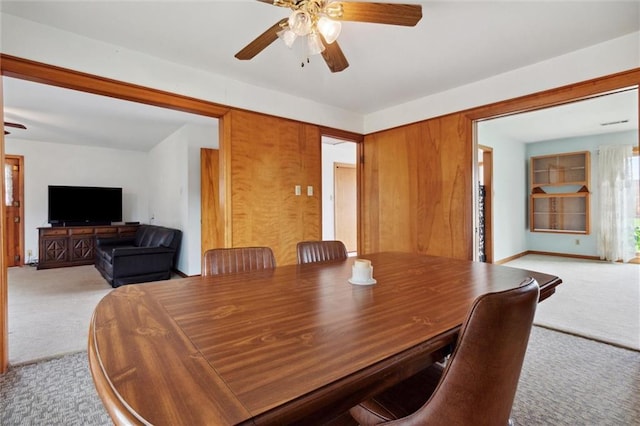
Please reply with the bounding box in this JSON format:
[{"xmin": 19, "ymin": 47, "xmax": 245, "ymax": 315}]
[{"xmin": 5, "ymin": 139, "xmax": 148, "ymax": 260}]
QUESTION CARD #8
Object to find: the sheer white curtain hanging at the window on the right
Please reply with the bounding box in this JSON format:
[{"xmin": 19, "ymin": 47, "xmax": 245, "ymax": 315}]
[{"xmin": 597, "ymin": 145, "xmax": 635, "ymax": 262}]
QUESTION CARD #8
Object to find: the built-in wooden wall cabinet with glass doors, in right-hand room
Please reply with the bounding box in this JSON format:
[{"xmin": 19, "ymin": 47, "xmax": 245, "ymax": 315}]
[{"xmin": 529, "ymin": 151, "xmax": 590, "ymax": 234}]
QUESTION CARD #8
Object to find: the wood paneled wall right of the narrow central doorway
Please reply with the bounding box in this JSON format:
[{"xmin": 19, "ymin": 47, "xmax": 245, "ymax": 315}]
[{"xmin": 360, "ymin": 113, "xmax": 473, "ymax": 259}]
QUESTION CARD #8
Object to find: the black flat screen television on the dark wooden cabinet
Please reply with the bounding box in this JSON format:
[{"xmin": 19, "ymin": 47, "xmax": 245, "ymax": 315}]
[{"xmin": 48, "ymin": 185, "xmax": 122, "ymax": 226}]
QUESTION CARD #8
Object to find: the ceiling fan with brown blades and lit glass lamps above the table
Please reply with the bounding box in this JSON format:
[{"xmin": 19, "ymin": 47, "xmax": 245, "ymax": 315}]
[{"xmin": 235, "ymin": 0, "xmax": 422, "ymax": 72}]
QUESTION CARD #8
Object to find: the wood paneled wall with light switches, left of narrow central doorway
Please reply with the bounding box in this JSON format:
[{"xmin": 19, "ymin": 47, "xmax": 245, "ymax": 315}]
[{"xmin": 220, "ymin": 110, "xmax": 322, "ymax": 265}]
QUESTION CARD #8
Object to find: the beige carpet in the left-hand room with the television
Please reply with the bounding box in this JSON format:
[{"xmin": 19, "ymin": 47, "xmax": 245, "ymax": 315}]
[{"xmin": 8, "ymin": 265, "xmax": 112, "ymax": 365}]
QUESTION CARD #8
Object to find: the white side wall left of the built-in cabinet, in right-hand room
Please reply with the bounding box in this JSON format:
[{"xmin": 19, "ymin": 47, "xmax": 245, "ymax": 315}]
[{"xmin": 478, "ymin": 122, "xmax": 528, "ymax": 262}]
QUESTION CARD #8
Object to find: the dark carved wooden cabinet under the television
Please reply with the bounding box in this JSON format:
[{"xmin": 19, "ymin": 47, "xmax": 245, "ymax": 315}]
[{"xmin": 38, "ymin": 225, "xmax": 138, "ymax": 269}]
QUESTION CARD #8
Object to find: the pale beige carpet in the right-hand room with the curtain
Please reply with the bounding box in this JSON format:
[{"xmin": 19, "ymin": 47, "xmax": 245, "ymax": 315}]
[{"xmin": 505, "ymin": 254, "xmax": 640, "ymax": 350}]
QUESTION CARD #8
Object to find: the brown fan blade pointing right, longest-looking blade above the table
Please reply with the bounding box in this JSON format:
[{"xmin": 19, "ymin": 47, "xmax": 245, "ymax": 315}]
[{"xmin": 335, "ymin": 1, "xmax": 422, "ymax": 27}]
